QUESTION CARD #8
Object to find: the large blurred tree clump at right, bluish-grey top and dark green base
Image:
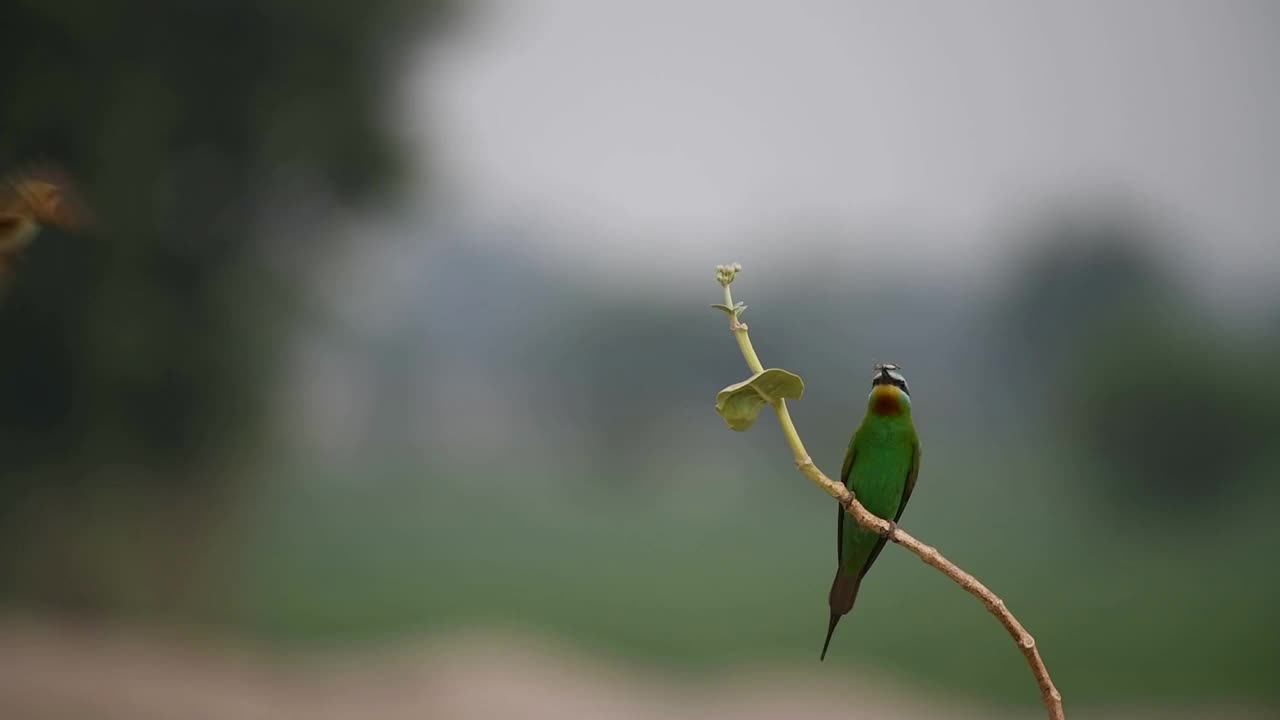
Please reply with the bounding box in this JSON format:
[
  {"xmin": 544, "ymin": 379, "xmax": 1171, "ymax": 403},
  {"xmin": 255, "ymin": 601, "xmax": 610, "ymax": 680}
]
[{"xmin": 992, "ymin": 202, "xmax": 1280, "ymax": 514}]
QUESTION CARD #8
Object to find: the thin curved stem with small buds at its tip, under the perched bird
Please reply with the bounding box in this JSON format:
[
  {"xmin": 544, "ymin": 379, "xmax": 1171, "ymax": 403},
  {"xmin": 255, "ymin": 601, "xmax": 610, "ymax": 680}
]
[{"xmin": 716, "ymin": 265, "xmax": 1066, "ymax": 720}]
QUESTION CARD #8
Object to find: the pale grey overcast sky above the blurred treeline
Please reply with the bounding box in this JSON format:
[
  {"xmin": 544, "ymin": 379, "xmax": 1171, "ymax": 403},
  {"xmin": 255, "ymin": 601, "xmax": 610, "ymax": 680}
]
[{"xmin": 408, "ymin": 0, "xmax": 1280, "ymax": 288}]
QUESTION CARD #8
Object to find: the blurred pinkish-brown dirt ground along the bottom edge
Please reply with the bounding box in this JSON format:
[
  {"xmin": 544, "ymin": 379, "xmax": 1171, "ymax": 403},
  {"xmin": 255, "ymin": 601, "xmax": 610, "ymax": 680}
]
[{"xmin": 0, "ymin": 609, "xmax": 1262, "ymax": 720}]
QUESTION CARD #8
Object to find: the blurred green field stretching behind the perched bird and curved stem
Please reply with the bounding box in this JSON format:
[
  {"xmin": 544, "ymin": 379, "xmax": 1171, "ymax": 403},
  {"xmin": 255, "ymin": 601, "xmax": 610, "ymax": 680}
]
[{"xmin": 225, "ymin": 448, "xmax": 1280, "ymax": 703}]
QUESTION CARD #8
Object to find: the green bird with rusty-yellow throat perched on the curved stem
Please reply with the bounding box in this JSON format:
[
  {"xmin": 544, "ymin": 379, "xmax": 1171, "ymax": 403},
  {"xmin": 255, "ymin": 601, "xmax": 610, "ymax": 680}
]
[{"xmin": 819, "ymin": 365, "xmax": 920, "ymax": 660}]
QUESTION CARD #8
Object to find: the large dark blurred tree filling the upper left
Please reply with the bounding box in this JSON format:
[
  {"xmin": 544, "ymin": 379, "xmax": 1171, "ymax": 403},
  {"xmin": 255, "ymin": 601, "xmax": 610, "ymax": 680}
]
[{"xmin": 0, "ymin": 0, "xmax": 453, "ymax": 605}]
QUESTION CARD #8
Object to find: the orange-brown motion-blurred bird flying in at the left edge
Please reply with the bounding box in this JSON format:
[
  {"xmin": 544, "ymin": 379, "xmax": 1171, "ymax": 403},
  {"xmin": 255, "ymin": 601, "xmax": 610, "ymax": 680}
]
[{"xmin": 0, "ymin": 170, "xmax": 86, "ymax": 286}]
